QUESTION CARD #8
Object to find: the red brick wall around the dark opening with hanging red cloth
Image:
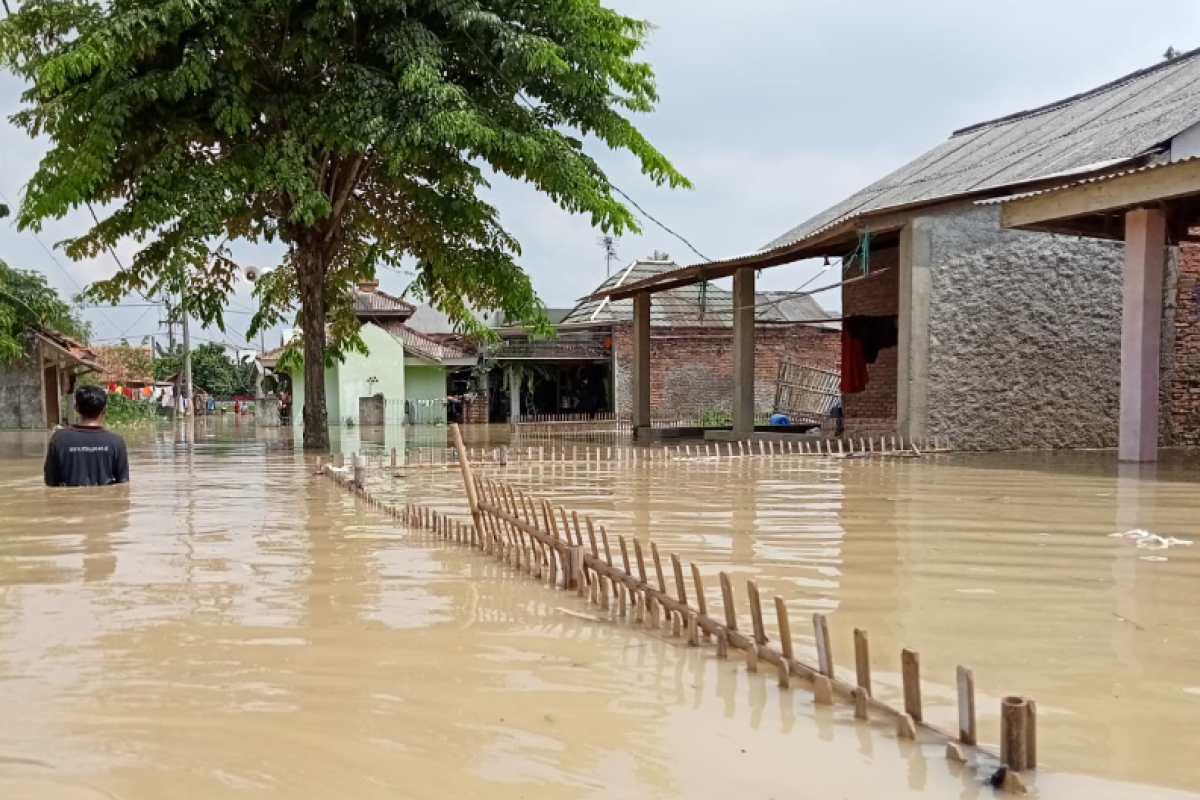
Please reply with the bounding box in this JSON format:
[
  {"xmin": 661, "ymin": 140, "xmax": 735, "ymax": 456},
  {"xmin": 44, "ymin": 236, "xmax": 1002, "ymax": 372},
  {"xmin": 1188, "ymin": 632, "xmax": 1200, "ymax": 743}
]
[{"xmin": 841, "ymin": 247, "xmax": 900, "ymax": 438}]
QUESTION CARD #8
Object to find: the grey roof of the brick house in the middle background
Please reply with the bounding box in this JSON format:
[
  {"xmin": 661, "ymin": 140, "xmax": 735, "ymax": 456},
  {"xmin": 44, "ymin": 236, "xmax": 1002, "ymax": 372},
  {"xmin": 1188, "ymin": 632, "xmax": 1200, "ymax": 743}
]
[{"xmin": 563, "ymin": 260, "xmax": 829, "ymax": 327}]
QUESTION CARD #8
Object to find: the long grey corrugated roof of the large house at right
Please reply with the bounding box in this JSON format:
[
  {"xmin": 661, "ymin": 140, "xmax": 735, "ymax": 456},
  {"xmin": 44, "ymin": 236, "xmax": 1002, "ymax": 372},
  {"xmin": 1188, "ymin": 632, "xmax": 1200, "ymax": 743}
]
[{"xmin": 767, "ymin": 50, "xmax": 1200, "ymax": 249}]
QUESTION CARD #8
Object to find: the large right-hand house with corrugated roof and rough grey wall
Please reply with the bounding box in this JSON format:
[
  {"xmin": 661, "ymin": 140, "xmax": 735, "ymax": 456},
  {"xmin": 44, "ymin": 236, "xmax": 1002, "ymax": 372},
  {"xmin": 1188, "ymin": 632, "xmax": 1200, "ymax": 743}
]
[{"xmin": 592, "ymin": 53, "xmax": 1200, "ymax": 449}]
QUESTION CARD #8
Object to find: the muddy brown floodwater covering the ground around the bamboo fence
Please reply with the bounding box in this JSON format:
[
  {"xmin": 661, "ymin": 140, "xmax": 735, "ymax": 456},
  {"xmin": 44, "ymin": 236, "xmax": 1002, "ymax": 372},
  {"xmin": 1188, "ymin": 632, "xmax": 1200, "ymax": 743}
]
[{"xmin": 0, "ymin": 421, "xmax": 1200, "ymax": 800}]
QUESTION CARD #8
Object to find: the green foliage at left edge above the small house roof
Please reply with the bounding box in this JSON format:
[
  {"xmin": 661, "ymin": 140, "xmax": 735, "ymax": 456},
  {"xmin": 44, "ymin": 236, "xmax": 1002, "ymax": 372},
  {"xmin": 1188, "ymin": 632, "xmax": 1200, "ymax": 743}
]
[{"xmin": 0, "ymin": 261, "xmax": 91, "ymax": 363}]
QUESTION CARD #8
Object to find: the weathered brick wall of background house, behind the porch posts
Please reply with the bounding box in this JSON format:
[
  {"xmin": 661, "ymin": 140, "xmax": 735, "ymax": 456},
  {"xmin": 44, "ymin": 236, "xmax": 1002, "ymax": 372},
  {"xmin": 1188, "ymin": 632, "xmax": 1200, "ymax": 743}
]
[{"xmin": 613, "ymin": 321, "xmax": 840, "ymax": 416}]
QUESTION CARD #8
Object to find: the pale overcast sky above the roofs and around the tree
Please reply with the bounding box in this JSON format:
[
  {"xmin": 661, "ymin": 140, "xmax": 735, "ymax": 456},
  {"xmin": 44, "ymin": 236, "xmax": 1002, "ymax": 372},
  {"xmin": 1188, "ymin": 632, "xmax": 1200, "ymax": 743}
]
[{"xmin": 0, "ymin": 0, "xmax": 1200, "ymax": 347}]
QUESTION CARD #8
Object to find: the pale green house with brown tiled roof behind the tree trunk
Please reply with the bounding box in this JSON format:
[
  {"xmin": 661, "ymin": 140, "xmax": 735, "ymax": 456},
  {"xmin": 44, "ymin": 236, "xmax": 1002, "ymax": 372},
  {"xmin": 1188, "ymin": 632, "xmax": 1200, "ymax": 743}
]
[{"xmin": 280, "ymin": 281, "xmax": 475, "ymax": 425}]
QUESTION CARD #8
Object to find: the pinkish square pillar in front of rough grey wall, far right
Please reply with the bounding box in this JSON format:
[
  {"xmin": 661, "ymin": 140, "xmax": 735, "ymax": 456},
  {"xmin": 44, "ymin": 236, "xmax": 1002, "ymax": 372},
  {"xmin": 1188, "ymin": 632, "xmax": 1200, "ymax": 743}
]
[{"xmin": 1120, "ymin": 209, "xmax": 1166, "ymax": 462}]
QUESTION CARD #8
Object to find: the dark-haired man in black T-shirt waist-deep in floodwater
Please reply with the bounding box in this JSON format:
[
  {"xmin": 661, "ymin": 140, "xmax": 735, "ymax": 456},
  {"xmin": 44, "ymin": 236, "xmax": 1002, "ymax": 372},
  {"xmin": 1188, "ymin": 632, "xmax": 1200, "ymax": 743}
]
[{"xmin": 46, "ymin": 386, "xmax": 130, "ymax": 486}]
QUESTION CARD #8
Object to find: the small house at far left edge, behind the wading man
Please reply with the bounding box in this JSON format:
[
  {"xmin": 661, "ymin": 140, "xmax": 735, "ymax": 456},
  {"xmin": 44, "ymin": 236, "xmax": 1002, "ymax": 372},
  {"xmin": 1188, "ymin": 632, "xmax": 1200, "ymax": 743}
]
[{"xmin": 0, "ymin": 327, "xmax": 100, "ymax": 429}]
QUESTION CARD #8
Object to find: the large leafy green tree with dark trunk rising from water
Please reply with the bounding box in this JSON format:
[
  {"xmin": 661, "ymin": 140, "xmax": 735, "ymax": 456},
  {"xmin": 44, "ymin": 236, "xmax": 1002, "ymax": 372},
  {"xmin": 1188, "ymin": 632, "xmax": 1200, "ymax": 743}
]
[{"xmin": 0, "ymin": 0, "xmax": 688, "ymax": 449}]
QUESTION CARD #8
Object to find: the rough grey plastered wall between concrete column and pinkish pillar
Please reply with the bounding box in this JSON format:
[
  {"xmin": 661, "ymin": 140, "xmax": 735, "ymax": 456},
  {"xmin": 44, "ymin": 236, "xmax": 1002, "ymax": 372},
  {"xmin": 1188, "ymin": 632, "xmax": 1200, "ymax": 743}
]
[{"xmin": 924, "ymin": 205, "xmax": 1123, "ymax": 450}]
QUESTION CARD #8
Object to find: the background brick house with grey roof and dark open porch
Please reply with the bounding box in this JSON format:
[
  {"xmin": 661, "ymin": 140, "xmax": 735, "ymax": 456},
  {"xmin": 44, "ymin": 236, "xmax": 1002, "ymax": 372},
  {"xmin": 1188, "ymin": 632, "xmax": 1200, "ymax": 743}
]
[{"xmin": 488, "ymin": 259, "xmax": 839, "ymax": 421}]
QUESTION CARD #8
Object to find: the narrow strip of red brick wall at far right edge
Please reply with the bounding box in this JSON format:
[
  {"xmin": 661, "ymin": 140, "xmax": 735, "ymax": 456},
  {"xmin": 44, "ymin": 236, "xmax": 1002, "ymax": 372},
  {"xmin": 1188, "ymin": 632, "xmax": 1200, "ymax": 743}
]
[{"xmin": 1163, "ymin": 242, "xmax": 1200, "ymax": 447}]
